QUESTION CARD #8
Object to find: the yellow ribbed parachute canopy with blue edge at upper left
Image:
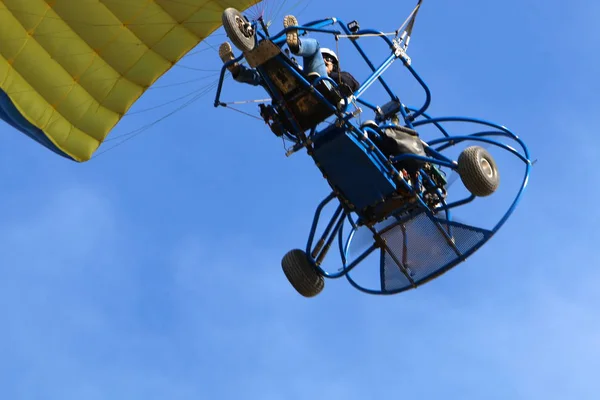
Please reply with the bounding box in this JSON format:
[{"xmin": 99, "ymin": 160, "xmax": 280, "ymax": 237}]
[{"xmin": 0, "ymin": 0, "xmax": 257, "ymax": 161}]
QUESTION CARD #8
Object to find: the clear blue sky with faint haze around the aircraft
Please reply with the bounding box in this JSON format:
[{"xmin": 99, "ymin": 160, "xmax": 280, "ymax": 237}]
[{"xmin": 0, "ymin": 0, "xmax": 600, "ymax": 400}]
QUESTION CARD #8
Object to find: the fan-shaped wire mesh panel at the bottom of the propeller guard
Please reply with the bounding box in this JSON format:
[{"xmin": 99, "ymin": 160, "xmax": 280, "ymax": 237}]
[{"xmin": 380, "ymin": 213, "xmax": 492, "ymax": 292}]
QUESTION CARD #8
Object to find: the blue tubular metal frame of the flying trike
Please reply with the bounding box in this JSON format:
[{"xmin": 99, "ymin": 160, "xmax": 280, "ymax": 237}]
[{"xmin": 215, "ymin": 8, "xmax": 532, "ymax": 294}]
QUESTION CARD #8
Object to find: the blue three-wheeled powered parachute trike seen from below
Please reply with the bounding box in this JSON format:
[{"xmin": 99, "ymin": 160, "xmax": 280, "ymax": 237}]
[{"xmin": 215, "ymin": 1, "xmax": 532, "ymax": 297}]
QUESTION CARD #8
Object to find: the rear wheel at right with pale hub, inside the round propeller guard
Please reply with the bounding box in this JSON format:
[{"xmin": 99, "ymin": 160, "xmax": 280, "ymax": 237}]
[{"xmin": 458, "ymin": 146, "xmax": 500, "ymax": 197}]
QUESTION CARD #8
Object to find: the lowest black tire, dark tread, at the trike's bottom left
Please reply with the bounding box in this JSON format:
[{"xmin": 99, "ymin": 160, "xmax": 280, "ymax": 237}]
[{"xmin": 281, "ymin": 249, "xmax": 325, "ymax": 297}]
